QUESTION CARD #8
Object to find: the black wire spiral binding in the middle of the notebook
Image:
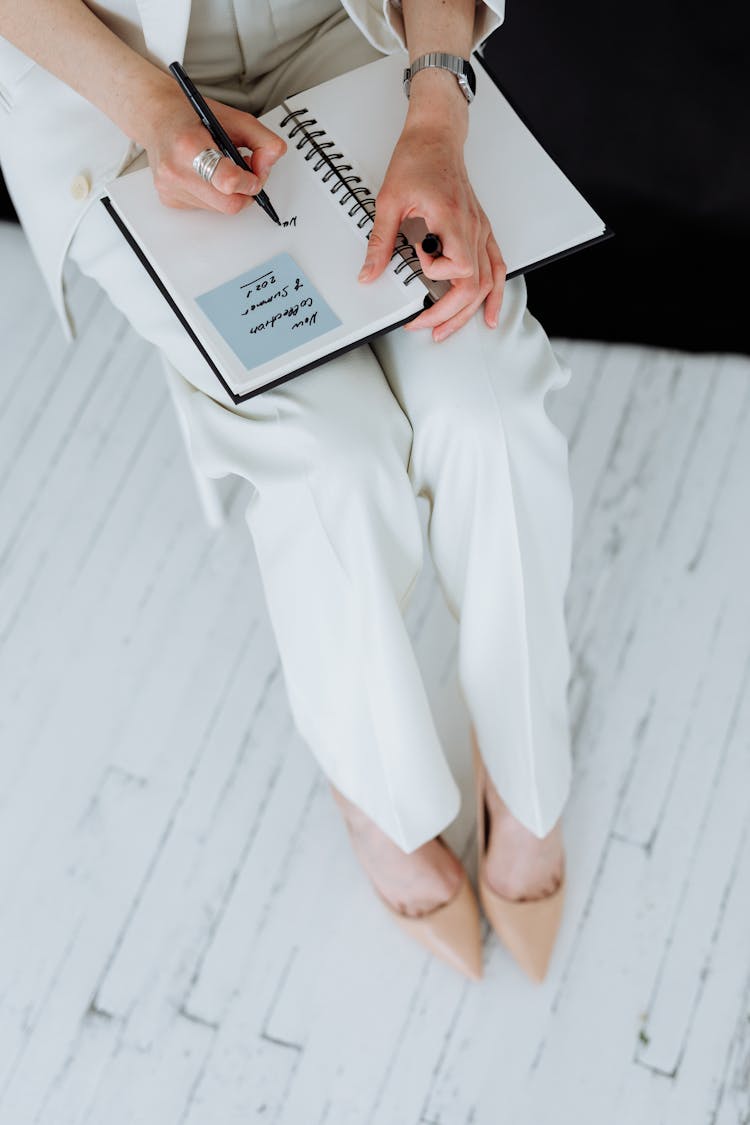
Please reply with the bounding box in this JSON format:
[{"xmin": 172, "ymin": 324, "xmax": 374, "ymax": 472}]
[{"xmin": 280, "ymin": 102, "xmax": 424, "ymax": 285}]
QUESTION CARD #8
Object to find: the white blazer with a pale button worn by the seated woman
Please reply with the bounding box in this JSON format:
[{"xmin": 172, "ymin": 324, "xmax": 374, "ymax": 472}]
[{"xmin": 0, "ymin": 0, "xmax": 505, "ymax": 340}]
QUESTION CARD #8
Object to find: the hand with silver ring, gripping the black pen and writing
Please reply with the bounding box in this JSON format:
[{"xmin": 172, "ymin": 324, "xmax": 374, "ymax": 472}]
[{"xmin": 139, "ymin": 88, "xmax": 287, "ymax": 215}]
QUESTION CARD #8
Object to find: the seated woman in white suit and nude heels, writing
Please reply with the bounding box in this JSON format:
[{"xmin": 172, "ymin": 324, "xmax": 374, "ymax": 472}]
[{"xmin": 0, "ymin": 0, "xmax": 571, "ymax": 979}]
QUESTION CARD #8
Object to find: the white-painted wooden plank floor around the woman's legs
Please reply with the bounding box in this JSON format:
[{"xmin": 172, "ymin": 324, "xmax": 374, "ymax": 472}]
[{"xmin": 0, "ymin": 226, "xmax": 750, "ymax": 1125}]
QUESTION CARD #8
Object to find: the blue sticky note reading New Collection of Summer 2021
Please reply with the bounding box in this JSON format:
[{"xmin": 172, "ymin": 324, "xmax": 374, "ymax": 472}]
[{"xmin": 196, "ymin": 253, "xmax": 341, "ymax": 368}]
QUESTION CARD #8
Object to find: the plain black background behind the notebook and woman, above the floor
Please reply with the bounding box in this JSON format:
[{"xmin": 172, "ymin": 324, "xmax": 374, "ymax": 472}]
[{"xmin": 0, "ymin": 0, "xmax": 750, "ymax": 353}]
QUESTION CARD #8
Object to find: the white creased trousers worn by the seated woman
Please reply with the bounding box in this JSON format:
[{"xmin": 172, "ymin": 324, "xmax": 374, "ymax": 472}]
[{"xmin": 71, "ymin": 6, "xmax": 572, "ymax": 852}]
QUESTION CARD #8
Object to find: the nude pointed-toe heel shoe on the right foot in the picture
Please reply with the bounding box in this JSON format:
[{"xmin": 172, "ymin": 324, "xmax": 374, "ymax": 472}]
[{"xmin": 471, "ymin": 727, "xmax": 566, "ymax": 982}]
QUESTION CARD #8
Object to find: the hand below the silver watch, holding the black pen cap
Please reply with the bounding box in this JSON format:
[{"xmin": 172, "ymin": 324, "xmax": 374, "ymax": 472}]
[{"xmin": 360, "ymin": 122, "xmax": 506, "ymax": 341}]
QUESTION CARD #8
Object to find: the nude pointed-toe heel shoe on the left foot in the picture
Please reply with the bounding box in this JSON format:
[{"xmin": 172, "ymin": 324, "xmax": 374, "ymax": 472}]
[{"xmin": 372, "ymin": 836, "xmax": 482, "ymax": 981}]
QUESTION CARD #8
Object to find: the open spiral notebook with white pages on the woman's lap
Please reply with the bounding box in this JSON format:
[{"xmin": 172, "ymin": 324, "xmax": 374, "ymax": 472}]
[{"xmin": 102, "ymin": 52, "xmax": 612, "ymax": 403}]
